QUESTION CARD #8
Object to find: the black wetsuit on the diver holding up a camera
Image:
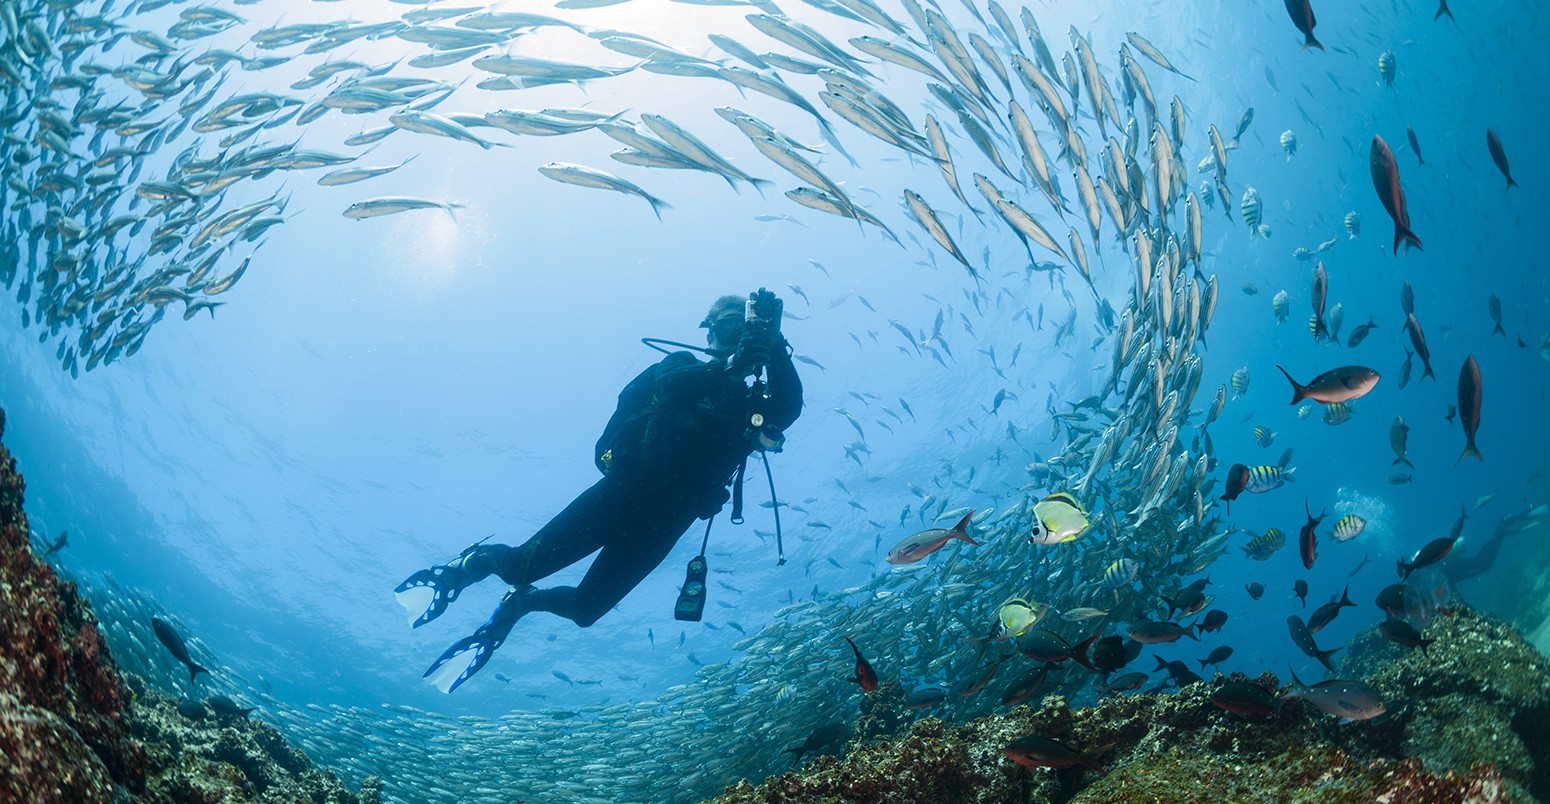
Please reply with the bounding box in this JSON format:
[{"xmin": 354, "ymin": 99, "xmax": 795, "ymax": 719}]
[{"xmin": 465, "ymin": 342, "xmax": 801, "ymax": 627}]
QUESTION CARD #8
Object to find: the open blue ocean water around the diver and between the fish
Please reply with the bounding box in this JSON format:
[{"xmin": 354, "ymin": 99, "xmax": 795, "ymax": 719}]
[{"xmin": 0, "ymin": 0, "xmax": 1550, "ymax": 798}]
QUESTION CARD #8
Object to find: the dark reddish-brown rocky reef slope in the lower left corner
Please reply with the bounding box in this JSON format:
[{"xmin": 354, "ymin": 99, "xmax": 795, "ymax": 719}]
[{"xmin": 0, "ymin": 411, "xmax": 381, "ymax": 804}]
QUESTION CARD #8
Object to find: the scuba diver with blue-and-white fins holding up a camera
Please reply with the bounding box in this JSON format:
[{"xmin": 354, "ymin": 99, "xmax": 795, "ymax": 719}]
[{"xmin": 395, "ymin": 288, "xmax": 801, "ymax": 692}]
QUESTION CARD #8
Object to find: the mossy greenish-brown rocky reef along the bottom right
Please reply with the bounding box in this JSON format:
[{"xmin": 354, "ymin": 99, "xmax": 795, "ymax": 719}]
[{"xmin": 716, "ymin": 606, "xmax": 1550, "ymax": 804}]
